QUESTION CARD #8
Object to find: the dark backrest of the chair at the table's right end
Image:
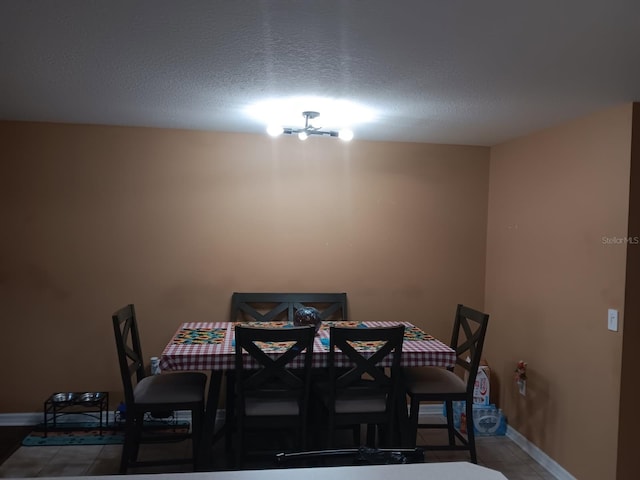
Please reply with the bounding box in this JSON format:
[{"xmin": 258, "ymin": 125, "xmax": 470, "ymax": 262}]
[{"xmin": 450, "ymin": 304, "xmax": 489, "ymax": 393}]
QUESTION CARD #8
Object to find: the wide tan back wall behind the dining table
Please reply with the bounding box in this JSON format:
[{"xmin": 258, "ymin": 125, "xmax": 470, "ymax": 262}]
[{"xmin": 0, "ymin": 122, "xmax": 490, "ymax": 413}]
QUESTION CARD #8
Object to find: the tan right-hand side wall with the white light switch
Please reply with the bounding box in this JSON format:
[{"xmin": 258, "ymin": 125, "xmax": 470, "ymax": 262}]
[{"xmin": 485, "ymin": 105, "xmax": 632, "ymax": 480}]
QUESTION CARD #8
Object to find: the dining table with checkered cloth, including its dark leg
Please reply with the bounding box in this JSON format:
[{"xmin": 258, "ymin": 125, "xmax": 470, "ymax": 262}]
[{"xmin": 160, "ymin": 320, "xmax": 456, "ymax": 466}]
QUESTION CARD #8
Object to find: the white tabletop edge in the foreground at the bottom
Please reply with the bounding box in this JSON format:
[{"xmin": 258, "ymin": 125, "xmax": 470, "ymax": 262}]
[{"xmin": 15, "ymin": 462, "xmax": 507, "ymax": 480}]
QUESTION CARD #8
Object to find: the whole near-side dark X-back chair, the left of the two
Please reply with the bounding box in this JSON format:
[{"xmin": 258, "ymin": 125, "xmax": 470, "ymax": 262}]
[{"xmin": 231, "ymin": 325, "xmax": 315, "ymax": 467}]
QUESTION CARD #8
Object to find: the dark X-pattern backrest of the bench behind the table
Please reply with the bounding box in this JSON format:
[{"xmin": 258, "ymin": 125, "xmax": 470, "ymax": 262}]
[{"xmin": 230, "ymin": 292, "xmax": 347, "ymax": 322}]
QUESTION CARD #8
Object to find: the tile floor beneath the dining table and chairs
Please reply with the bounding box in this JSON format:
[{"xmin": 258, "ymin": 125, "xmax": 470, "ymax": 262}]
[{"xmin": 0, "ymin": 422, "xmax": 556, "ymax": 480}]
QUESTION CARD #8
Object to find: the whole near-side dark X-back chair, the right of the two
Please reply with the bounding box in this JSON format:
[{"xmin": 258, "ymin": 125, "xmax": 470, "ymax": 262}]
[{"xmin": 315, "ymin": 325, "xmax": 404, "ymax": 448}]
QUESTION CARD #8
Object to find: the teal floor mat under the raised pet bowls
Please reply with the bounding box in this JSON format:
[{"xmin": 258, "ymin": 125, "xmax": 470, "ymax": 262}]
[{"xmin": 22, "ymin": 422, "xmax": 189, "ymax": 447}]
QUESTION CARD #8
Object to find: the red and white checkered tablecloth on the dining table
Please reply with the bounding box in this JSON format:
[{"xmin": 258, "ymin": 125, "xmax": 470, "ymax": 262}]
[{"xmin": 160, "ymin": 322, "xmax": 456, "ymax": 370}]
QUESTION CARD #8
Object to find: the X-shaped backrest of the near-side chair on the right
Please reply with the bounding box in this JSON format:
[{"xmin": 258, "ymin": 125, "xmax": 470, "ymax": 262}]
[{"xmin": 329, "ymin": 325, "xmax": 404, "ymax": 408}]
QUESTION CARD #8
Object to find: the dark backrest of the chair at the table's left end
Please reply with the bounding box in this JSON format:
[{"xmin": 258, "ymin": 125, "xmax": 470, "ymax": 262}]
[{"xmin": 111, "ymin": 304, "xmax": 145, "ymax": 405}]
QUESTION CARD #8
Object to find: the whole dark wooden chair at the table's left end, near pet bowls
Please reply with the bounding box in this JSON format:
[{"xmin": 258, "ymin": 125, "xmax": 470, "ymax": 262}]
[{"xmin": 112, "ymin": 304, "xmax": 207, "ymax": 474}]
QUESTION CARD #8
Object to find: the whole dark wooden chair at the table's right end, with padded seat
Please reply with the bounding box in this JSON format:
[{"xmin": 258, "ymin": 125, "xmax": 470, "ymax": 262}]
[{"xmin": 403, "ymin": 305, "xmax": 489, "ymax": 463}]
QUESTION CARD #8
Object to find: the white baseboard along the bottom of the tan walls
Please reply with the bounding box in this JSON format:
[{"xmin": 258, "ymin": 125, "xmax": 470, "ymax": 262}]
[{"xmin": 0, "ymin": 404, "xmax": 576, "ymax": 480}]
